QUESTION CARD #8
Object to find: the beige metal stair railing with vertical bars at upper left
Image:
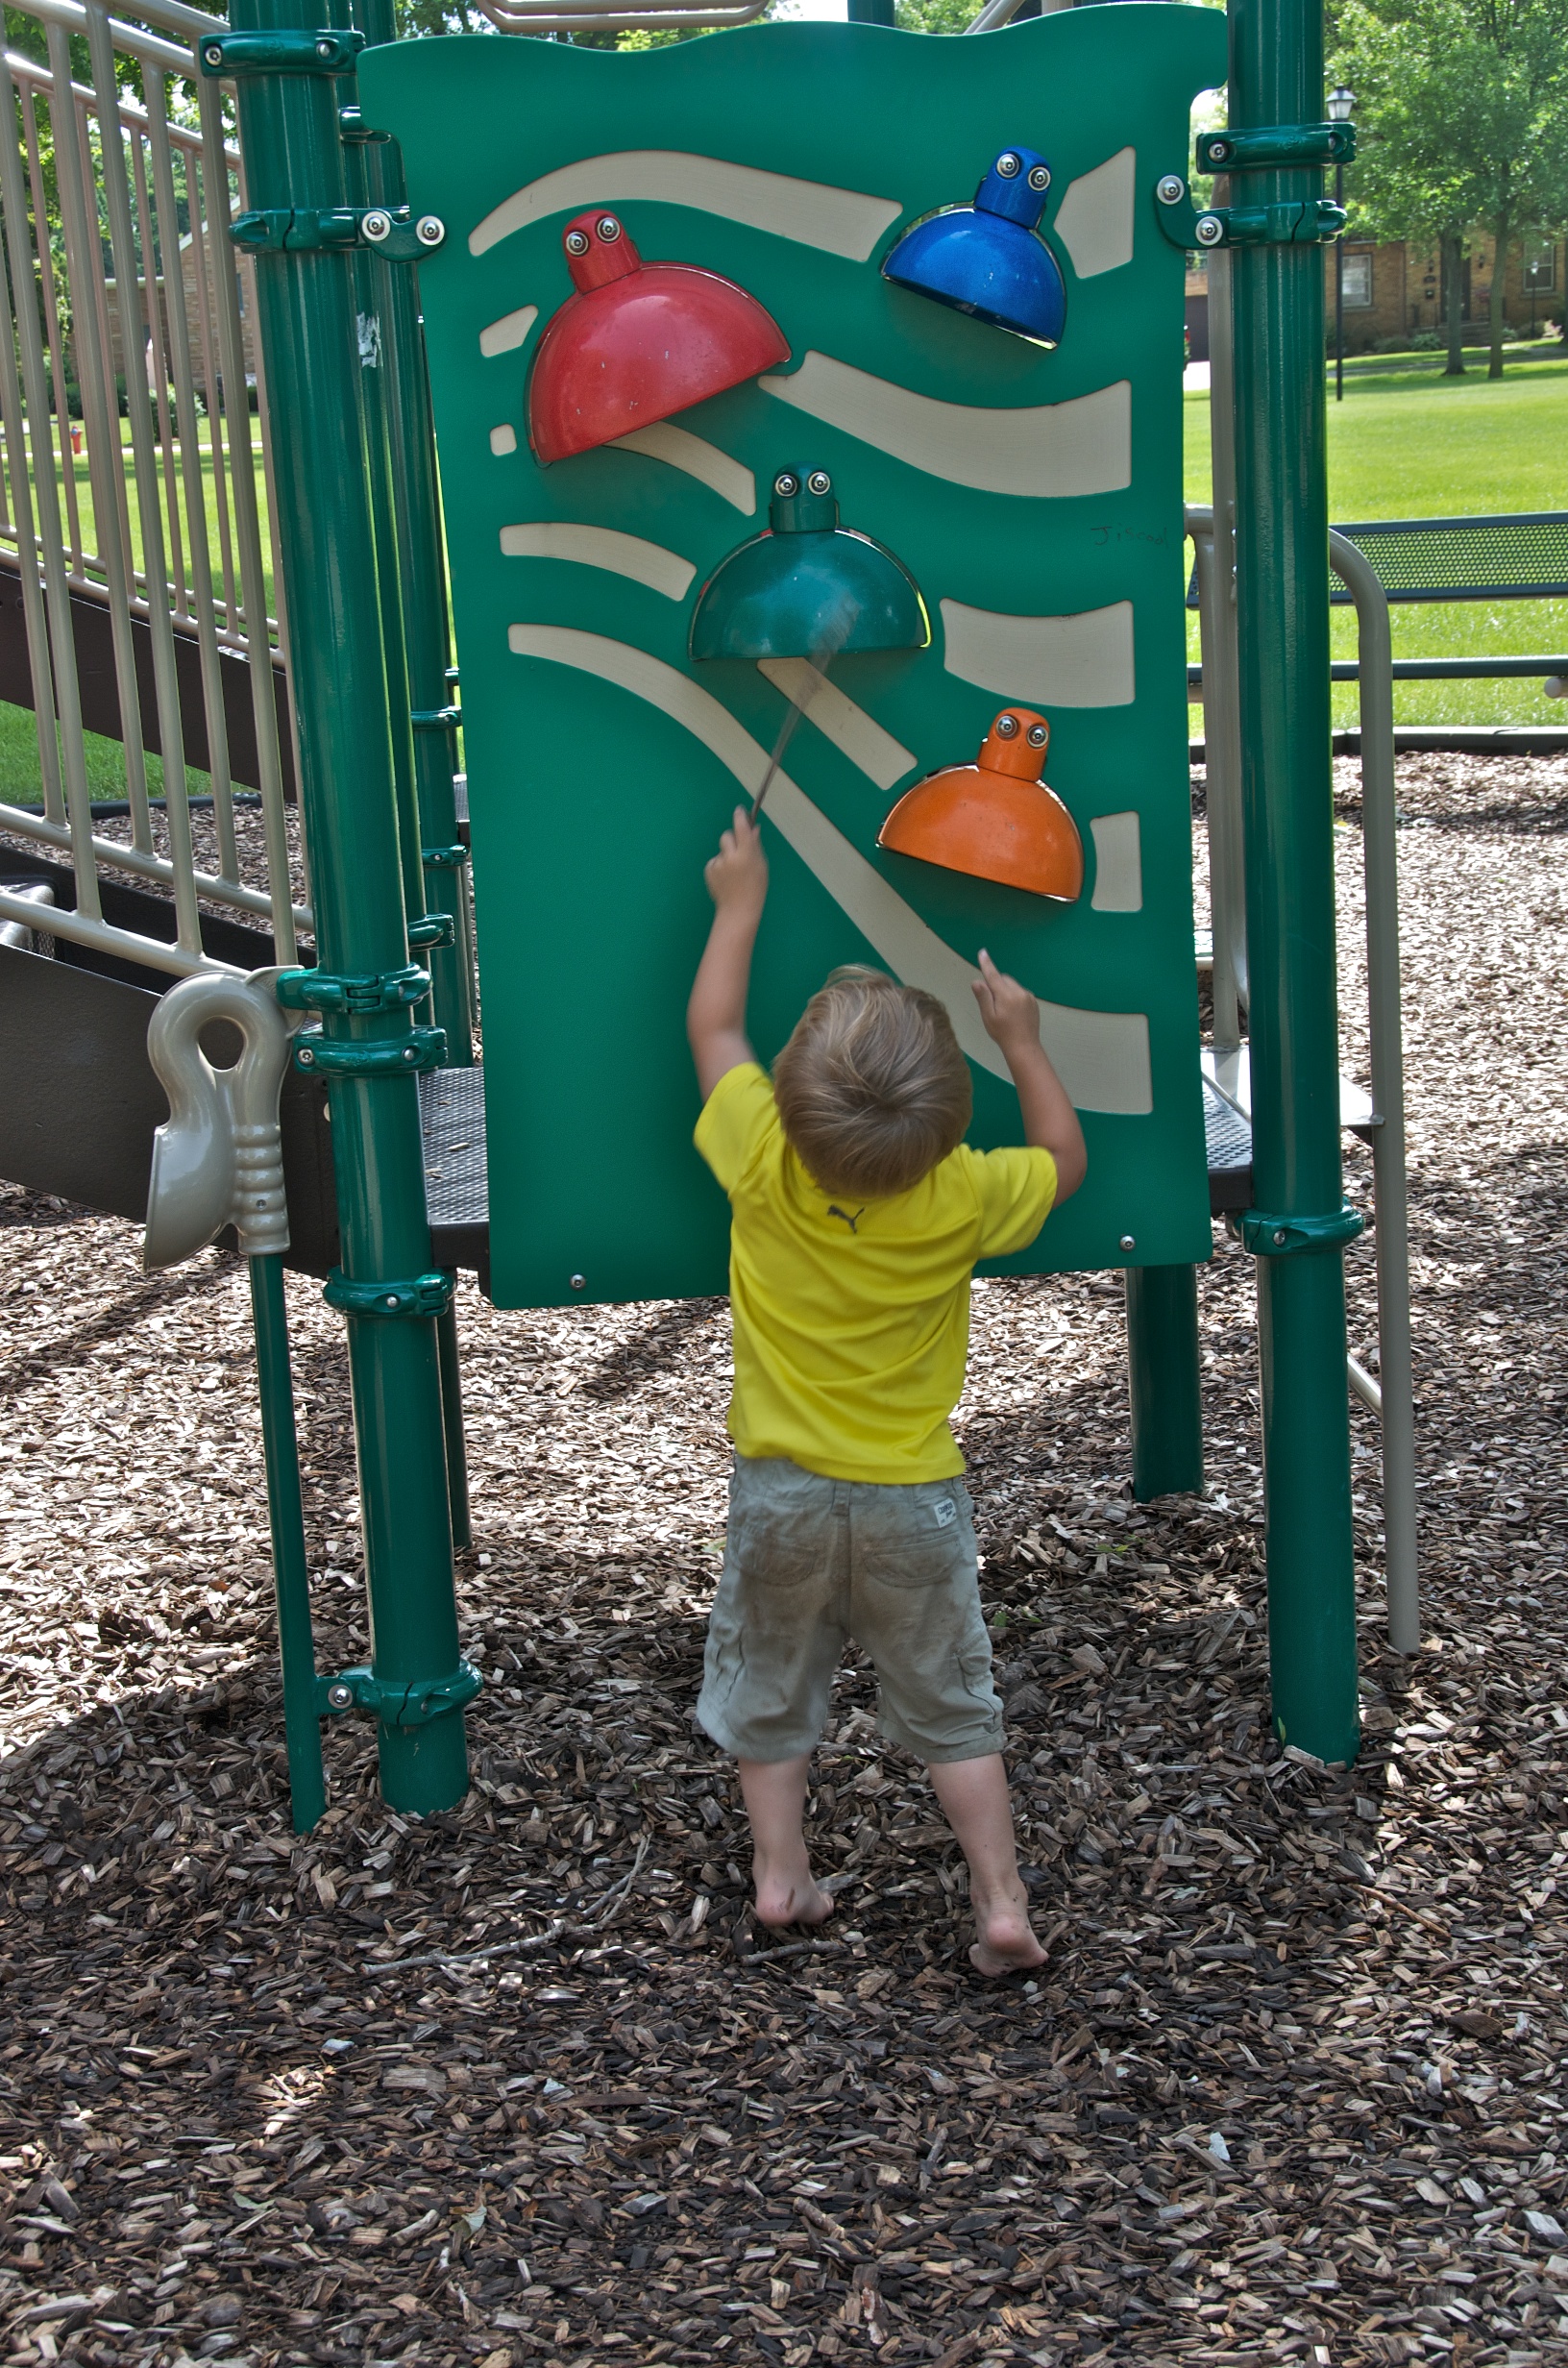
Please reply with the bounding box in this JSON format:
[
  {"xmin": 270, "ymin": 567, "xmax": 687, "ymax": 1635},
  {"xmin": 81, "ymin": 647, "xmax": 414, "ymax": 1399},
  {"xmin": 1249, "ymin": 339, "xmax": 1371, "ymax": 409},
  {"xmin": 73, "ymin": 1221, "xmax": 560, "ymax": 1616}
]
[{"xmin": 0, "ymin": 0, "xmax": 310, "ymax": 975}]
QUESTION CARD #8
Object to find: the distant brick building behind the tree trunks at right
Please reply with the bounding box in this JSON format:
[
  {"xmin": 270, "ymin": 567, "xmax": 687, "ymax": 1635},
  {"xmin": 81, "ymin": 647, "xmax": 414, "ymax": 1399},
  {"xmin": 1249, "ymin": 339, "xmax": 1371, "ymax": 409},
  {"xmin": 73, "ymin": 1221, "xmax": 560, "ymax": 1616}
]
[{"xmin": 1187, "ymin": 232, "xmax": 1568, "ymax": 362}]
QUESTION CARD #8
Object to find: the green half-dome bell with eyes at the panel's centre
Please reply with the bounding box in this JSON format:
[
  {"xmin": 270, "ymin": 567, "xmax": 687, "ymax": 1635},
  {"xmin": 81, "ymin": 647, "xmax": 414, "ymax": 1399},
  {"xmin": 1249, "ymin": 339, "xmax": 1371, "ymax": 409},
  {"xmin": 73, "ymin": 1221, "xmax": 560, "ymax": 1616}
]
[{"xmin": 689, "ymin": 469, "xmax": 931, "ymax": 658}]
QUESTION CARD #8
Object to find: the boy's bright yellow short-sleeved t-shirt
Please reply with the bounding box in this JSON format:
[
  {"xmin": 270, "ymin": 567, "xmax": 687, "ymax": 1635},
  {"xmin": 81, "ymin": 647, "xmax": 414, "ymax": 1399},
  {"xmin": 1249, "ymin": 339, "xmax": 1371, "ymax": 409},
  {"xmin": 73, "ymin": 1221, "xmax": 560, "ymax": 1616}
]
[{"xmin": 697, "ymin": 1061, "xmax": 1057, "ymax": 1482}]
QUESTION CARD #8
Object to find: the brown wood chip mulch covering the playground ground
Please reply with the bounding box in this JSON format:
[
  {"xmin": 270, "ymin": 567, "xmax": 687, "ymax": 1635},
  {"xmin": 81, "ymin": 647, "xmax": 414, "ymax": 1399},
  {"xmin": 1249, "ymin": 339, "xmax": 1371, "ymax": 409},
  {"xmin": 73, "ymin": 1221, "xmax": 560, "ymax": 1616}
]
[{"xmin": 0, "ymin": 757, "xmax": 1568, "ymax": 2368}]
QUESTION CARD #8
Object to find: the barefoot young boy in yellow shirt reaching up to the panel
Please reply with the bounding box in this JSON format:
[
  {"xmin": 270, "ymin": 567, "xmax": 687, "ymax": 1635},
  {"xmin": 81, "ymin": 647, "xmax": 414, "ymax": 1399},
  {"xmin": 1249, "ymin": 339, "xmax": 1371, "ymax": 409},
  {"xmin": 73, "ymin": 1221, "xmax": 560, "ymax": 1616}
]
[{"xmin": 687, "ymin": 807, "xmax": 1088, "ymax": 1975}]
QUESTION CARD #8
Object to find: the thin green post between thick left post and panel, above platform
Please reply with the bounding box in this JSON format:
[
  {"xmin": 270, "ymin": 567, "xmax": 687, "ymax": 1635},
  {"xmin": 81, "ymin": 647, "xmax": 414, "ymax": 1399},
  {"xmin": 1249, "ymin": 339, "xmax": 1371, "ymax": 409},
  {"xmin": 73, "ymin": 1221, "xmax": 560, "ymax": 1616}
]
[{"xmin": 355, "ymin": 0, "xmax": 477, "ymax": 1068}]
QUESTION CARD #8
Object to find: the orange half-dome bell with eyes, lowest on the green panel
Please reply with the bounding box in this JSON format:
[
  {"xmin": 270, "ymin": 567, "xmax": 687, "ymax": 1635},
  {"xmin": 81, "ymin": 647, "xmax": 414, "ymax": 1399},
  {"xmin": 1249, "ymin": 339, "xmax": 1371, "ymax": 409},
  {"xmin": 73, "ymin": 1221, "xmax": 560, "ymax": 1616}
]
[{"xmin": 876, "ymin": 708, "xmax": 1083, "ymax": 904}]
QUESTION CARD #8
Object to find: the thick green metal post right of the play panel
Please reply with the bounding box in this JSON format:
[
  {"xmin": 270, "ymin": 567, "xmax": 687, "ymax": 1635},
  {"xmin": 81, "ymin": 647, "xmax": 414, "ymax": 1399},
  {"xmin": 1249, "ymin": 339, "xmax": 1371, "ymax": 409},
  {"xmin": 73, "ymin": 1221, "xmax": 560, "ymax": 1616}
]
[{"xmin": 1229, "ymin": 0, "xmax": 1360, "ymax": 1762}]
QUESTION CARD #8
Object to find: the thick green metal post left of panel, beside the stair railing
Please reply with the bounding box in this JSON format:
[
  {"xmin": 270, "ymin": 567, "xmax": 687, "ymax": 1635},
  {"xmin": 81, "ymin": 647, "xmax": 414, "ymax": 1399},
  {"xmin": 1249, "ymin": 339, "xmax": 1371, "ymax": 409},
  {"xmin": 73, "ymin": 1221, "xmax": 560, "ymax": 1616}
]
[{"xmin": 233, "ymin": 0, "xmax": 467, "ymax": 1812}]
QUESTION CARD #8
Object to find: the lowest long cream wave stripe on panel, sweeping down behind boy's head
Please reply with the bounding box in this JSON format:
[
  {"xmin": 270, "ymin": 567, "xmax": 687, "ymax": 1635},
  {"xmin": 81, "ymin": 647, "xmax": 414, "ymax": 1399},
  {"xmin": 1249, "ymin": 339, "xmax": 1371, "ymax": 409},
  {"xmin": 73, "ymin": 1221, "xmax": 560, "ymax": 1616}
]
[{"xmin": 507, "ymin": 625, "xmax": 1154, "ymax": 1118}]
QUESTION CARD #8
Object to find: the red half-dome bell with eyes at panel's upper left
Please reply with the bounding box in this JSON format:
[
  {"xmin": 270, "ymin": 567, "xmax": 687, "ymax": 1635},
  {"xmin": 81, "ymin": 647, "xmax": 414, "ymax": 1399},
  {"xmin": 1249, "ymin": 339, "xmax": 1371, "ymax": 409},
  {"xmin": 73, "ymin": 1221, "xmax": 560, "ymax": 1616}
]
[{"xmin": 528, "ymin": 210, "xmax": 789, "ymax": 461}]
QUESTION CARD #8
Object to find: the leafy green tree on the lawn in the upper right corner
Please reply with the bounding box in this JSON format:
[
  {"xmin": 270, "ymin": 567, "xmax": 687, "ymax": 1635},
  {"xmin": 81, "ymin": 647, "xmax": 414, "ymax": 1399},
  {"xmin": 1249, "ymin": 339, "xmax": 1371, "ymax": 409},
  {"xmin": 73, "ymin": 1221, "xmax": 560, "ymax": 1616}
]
[{"xmin": 1331, "ymin": 0, "xmax": 1568, "ymax": 379}]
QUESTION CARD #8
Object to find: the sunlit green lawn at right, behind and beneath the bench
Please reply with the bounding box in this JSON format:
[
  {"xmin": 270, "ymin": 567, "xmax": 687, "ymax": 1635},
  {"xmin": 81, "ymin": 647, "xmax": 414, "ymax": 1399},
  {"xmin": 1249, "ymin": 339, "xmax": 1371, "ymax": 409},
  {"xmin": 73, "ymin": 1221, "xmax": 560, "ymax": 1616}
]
[{"xmin": 1185, "ymin": 360, "xmax": 1568, "ymax": 727}]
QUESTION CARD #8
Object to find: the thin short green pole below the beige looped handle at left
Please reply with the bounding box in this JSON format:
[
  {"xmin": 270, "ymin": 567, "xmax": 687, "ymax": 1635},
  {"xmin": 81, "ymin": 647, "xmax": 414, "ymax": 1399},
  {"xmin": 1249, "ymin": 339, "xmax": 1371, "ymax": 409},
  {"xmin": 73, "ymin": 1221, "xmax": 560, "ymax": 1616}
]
[{"xmin": 251, "ymin": 1257, "xmax": 327, "ymax": 1833}]
